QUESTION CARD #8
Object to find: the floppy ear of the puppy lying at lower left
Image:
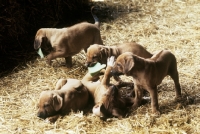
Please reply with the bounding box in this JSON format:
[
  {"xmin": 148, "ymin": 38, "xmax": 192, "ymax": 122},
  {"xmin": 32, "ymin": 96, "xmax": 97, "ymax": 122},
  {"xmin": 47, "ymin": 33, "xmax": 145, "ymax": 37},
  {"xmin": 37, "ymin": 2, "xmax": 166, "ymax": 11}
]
[{"xmin": 53, "ymin": 94, "xmax": 63, "ymax": 111}]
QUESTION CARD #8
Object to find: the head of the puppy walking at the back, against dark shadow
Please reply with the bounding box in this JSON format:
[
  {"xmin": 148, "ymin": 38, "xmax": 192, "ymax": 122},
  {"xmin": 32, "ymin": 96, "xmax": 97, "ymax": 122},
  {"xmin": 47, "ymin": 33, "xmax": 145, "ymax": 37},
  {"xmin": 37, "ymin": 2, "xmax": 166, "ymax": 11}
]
[{"xmin": 34, "ymin": 29, "xmax": 47, "ymax": 50}]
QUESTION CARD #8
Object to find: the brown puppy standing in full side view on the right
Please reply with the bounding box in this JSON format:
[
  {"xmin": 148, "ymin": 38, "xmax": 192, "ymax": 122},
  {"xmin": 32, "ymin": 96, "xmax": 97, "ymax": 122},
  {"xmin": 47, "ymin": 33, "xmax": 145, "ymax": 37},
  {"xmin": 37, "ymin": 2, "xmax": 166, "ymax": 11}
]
[{"xmin": 112, "ymin": 50, "xmax": 181, "ymax": 115}]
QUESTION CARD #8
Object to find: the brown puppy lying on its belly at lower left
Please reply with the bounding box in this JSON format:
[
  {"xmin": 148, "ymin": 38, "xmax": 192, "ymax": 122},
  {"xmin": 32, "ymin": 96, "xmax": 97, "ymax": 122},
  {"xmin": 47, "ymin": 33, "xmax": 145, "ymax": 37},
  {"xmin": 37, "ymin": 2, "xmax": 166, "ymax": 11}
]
[{"xmin": 37, "ymin": 79, "xmax": 89, "ymax": 122}]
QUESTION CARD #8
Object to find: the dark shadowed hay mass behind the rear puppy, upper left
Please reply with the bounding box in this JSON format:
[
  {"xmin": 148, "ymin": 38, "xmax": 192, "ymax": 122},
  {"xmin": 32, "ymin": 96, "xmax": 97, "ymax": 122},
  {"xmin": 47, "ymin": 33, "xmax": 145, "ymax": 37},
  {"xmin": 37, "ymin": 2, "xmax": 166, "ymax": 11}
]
[{"xmin": 0, "ymin": 0, "xmax": 91, "ymax": 74}]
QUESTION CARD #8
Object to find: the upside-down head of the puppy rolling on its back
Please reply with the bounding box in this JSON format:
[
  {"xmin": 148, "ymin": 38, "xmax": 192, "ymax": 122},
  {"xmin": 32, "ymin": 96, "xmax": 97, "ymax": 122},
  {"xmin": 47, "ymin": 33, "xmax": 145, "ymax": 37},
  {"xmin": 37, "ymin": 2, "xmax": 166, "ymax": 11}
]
[{"xmin": 92, "ymin": 85, "xmax": 122, "ymax": 120}]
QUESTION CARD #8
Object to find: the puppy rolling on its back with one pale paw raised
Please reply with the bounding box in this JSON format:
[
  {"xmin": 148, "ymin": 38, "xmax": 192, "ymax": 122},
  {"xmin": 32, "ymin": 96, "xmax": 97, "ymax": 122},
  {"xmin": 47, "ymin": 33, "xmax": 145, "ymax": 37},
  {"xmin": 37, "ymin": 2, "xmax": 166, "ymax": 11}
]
[{"xmin": 82, "ymin": 57, "xmax": 133, "ymax": 119}]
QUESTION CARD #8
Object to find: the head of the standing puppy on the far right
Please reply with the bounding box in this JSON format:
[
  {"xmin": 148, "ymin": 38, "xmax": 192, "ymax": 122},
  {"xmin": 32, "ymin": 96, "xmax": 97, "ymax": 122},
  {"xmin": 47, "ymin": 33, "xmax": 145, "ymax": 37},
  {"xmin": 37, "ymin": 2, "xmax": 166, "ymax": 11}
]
[{"xmin": 111, "ymin": 52, "xmax": 134, "ymax": 76}]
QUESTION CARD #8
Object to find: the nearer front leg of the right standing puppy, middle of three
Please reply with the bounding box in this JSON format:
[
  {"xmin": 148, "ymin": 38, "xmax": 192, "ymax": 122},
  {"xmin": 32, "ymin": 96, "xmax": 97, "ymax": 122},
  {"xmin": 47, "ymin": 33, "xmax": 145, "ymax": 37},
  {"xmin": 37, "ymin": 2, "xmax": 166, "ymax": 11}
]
[{"xmin": 148, "ymin": 87, "xmax": 160, "ymax": 115}]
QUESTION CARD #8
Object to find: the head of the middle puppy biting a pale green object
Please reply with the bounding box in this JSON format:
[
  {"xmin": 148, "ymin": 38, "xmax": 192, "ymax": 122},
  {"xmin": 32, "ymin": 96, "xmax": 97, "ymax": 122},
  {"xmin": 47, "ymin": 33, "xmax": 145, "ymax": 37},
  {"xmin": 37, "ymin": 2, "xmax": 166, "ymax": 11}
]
[{"xmin": 86, "ymin": 44, "xmax": 107, "ymax": 67}]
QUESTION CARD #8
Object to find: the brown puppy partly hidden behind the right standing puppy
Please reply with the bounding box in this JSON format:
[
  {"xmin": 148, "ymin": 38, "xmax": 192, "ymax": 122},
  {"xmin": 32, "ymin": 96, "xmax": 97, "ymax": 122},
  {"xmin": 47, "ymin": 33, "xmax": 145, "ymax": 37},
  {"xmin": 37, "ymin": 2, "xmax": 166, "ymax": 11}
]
[{"xmin": 86, "ymin": 42, "xmax": 152, "ymax": 67}]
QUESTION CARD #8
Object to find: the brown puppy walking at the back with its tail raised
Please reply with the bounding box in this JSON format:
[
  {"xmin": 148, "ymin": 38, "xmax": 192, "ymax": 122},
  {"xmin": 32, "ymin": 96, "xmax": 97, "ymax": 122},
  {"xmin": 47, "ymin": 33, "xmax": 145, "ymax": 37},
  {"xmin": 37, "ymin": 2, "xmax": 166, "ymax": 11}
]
[{"xmin": 34, "ymin": 6, "xmax": 103, "ymax": 67}]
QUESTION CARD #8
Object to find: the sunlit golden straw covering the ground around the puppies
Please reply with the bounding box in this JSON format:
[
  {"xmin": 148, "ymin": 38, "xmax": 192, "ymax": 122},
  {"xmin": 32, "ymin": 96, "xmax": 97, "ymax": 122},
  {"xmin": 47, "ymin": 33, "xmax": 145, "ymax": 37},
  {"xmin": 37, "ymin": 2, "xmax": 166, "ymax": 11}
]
[{"xmin": 0, "ymin": 0, "xmax": 200, "ymax": 134}]
